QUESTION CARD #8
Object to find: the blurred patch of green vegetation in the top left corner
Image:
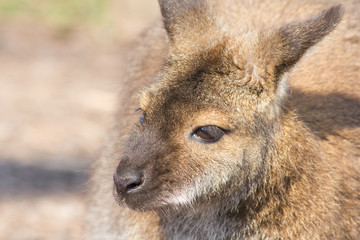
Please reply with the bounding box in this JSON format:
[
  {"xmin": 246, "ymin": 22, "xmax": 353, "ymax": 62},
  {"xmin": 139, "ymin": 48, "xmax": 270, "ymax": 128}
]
[{"xmin": 0, "ymin": 0, "xmax": 109, "ymax": 29}]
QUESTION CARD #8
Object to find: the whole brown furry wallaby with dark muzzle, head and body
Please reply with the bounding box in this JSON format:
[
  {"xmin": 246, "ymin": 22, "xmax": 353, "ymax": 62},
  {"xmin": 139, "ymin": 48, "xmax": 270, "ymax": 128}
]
[{"xmin": 88, "ymin": 0, "xmax": 360, "ymax": 240}]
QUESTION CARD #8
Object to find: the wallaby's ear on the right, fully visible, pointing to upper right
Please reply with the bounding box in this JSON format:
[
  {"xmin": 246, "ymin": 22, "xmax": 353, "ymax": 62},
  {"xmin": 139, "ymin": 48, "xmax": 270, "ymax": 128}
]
[{"xmin": 276, "ymin": 4, "xmax": 343, "ymax": 75}]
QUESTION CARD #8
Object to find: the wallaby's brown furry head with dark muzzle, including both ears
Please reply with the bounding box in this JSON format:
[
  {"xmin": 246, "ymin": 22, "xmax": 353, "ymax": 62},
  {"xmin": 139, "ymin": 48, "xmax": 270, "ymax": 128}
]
[{"xmin": 114, "ymin": 0, "xmax": 342, "ymax": 210}]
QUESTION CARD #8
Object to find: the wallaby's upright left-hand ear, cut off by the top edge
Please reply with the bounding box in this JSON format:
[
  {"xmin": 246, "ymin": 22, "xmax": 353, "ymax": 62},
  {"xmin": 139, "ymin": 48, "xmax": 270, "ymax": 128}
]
[{"xmin": 159, "ymin": 0, "xmax": 212, "ymax": 43}]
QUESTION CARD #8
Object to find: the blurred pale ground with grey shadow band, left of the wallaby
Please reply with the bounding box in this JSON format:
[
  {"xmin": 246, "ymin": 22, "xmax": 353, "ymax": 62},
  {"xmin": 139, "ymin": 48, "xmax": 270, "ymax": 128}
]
[{"xmin": 0, "ymin": 0, "xmax": 159, "ymax": 240}]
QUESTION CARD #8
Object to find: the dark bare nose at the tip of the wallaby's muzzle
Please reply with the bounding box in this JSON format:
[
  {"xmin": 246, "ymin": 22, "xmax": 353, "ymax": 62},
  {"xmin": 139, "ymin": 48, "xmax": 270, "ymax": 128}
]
[{"xmin": 113, "ymin": 171, "xmax": 144, "ymax": 194}]
